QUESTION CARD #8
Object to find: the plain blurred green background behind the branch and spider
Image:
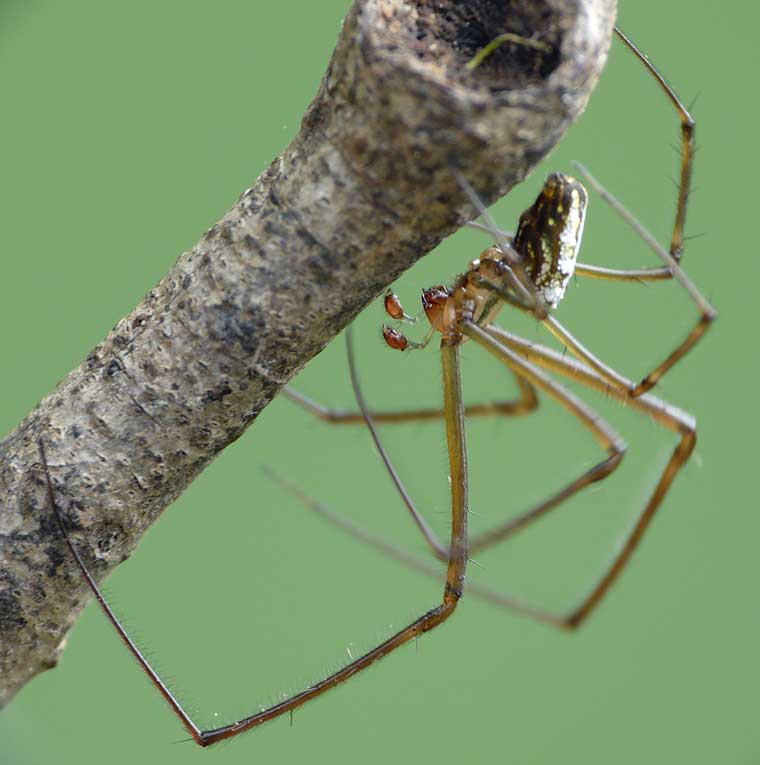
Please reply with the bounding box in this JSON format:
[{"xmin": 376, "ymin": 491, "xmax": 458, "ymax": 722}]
[{"xmin": 0, "ymin": 0, "xmax": 760, "ymax": 765}]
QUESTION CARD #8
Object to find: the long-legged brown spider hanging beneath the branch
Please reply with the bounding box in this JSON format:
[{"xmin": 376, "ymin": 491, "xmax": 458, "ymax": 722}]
[{"xmin": 39, "ymin": 25, "xmax": 715, "ymax": 747}]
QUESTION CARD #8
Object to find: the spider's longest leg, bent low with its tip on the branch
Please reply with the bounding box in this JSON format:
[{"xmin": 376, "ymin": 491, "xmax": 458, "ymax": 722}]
[{"xmin": 38, "ymin": 346, "xmax": 467, "ymax": 747}]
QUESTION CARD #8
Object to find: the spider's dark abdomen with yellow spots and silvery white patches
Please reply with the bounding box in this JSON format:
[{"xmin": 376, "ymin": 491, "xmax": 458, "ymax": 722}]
[{"xmin": 513, "ymin": 173, "xmax": 588, "ymax": 307}]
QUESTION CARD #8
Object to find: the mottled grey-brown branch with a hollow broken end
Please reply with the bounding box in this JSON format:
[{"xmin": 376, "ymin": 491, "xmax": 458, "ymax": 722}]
[{"xmin": 0, "ymin": 0, "xmax": 616, "ymax": 706}]
